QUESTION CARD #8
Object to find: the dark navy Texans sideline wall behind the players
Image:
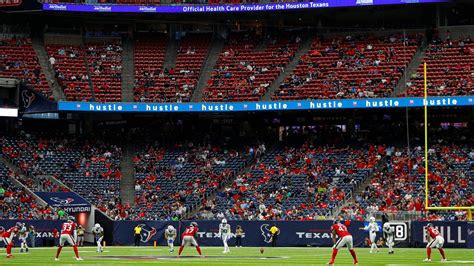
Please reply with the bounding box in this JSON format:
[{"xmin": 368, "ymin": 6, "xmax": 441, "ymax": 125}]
[{"xmin": 0, "ymin": 220, "xmax": 466, "ymax": 248}]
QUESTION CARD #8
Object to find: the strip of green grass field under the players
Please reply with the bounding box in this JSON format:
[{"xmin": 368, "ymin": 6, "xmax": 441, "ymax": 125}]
[{"xmin": 0, "ymin": 247, "xmax": 474, "ymax": 266}]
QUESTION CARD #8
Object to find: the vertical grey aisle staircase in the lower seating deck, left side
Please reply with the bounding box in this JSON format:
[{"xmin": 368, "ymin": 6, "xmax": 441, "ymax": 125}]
[{"xmin": 120, "ymin": 141, "xmax": 135, "ymax": 205}]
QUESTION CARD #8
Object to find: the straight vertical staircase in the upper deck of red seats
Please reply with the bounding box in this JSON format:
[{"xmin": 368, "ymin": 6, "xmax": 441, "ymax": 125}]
[{"xmin": 122, "ymin": 35, "xmax": 135, "ymax": 102}]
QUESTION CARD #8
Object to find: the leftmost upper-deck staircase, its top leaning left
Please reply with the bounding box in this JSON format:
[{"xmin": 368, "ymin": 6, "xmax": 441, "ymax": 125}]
[{"xmin": 31, "ymin": 38, "xmax": 66, "ymax": 101}]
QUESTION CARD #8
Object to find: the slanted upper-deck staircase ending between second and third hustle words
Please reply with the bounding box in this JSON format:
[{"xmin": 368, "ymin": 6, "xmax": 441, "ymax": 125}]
[{"xmin": 191, "ymin": 39, "xmax": 224, "ymax": 102}]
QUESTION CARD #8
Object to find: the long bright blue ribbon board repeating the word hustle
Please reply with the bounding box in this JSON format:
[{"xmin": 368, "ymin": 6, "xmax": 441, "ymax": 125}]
[{"xmin": 58, "ymin": 96, "xmax": 474, "ymax": 113}]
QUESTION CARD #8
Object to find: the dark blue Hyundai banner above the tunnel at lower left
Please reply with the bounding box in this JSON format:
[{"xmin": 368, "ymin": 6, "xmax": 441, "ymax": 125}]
[{"xmin": 35, "ymin": 192, "xmax": 91, "ymax": 213}]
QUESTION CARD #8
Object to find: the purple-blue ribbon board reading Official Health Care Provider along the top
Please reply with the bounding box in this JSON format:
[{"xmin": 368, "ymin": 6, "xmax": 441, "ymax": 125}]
[{"xmin": 42, "ymin": 0, "xmax": 448, "ymax": 13}]
